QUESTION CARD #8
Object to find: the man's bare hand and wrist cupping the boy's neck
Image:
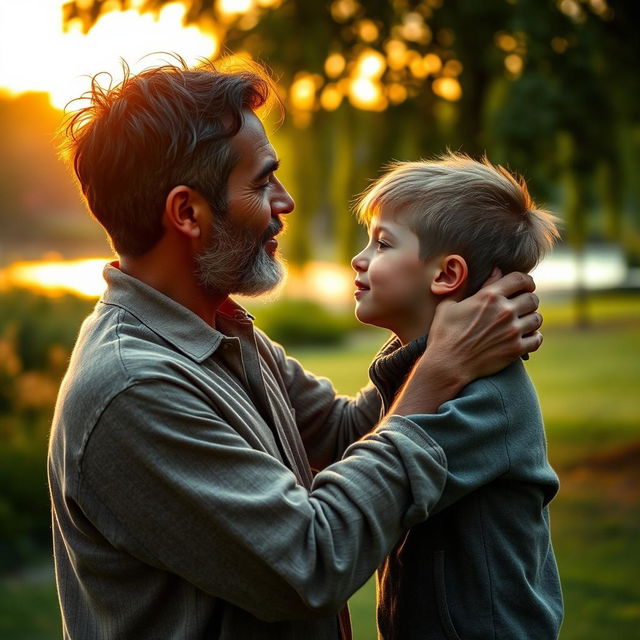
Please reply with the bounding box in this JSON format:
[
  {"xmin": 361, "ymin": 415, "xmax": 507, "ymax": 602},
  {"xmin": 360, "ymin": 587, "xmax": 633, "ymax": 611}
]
[{"xmin": 389, "ymin": 272, "xmax": 542, "ymax": 416}]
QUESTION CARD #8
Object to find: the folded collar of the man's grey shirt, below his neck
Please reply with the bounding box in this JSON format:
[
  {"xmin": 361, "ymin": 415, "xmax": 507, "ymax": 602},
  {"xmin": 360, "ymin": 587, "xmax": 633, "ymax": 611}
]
[{"xmin": 100, "ymin": 262, "xmax": 253, "ymax": 362}]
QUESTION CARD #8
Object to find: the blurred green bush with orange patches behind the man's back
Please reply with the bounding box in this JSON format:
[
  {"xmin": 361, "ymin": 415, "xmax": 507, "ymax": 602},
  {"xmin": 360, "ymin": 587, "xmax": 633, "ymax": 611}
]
[{"xmin": 0, "ymin": 290, "xmax": 94, "ymax": 569}]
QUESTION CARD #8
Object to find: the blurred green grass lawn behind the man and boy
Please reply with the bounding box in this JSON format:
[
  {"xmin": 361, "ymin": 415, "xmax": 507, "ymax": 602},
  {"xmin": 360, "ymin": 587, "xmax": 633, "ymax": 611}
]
[{"xmin": 0, "ymin": 295, "xmax": 640, "ymax": 640}]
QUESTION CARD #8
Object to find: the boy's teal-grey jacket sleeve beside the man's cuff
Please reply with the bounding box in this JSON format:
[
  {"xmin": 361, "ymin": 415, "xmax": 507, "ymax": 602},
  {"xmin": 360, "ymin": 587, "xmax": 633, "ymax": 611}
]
[{"xmin": 407, "ymin": 378, "xmax": 511, "ymax": 512}]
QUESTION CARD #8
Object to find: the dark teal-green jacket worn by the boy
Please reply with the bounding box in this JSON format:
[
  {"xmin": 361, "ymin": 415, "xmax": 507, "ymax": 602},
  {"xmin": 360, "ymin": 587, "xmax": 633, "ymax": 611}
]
[{"xmin": 370, "ymin": 338, "xmax": 563, "ymax": 640}]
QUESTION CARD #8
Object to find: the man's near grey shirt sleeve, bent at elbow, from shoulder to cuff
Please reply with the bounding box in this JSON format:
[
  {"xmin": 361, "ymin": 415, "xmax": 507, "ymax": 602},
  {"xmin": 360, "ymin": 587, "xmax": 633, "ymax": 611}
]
[{"xmin": 78, "ymin": 380, "xmax": 446, "ymax": 620}]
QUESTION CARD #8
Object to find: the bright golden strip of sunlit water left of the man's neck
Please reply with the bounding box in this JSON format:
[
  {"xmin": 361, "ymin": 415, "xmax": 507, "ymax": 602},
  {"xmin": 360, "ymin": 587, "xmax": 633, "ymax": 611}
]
[{"xmin": 2, "ymin": 258, "xmax": 109, "ymax": 298}]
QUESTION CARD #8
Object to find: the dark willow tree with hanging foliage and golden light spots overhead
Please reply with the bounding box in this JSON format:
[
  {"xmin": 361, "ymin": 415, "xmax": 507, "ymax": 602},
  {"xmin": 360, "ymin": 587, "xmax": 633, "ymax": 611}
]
[{"xmin": 66, "ymin": 0, "xmax": 640, "ymax": 280}]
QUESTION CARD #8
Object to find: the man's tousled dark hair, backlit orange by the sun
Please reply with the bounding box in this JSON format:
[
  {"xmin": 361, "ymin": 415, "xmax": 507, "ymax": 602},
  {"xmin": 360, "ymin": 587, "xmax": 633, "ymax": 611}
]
[{"xmin": 64, "ymin": 56, "xmax": 276, "ymax": 256}]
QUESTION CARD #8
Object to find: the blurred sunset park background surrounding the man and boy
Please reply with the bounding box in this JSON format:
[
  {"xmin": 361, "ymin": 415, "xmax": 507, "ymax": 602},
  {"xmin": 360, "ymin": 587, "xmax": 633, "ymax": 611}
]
[{"xmin": 0, "ymin": 0, "xmax": 640, "ymax": 640}]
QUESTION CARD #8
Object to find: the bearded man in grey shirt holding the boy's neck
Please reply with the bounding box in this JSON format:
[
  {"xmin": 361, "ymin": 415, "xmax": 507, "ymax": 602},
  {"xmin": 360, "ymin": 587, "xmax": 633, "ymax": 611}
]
[{"xmin": 49, "ymin": 57, "xmax": 541, "ymax": 640}]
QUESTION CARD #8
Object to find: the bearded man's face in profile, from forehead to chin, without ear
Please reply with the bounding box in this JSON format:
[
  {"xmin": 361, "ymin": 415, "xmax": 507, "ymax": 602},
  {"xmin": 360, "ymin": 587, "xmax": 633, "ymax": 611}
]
[{"xmin": 196, "ymin": 111, "xmax": 294, "ymax": 295}]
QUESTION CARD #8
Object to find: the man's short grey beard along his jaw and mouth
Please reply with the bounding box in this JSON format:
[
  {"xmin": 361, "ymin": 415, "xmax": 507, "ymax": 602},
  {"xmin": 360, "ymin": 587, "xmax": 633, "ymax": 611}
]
[{"xmin": 196, "ymin": 218, "xmax": 285, "ymax": 296}]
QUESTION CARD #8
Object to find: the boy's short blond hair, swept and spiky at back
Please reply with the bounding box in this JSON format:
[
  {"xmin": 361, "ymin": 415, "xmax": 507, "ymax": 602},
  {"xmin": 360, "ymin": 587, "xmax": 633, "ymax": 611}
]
[{"xmin": 356, "ymin": 152, "xmax": 559, "ymax": 295}]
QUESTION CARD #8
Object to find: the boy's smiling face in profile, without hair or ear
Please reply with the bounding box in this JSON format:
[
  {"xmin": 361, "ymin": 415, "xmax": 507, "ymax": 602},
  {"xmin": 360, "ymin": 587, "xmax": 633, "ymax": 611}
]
[{"xmin": 351, "ymin": 210, "xmax": 438, "ymax": 344}]
